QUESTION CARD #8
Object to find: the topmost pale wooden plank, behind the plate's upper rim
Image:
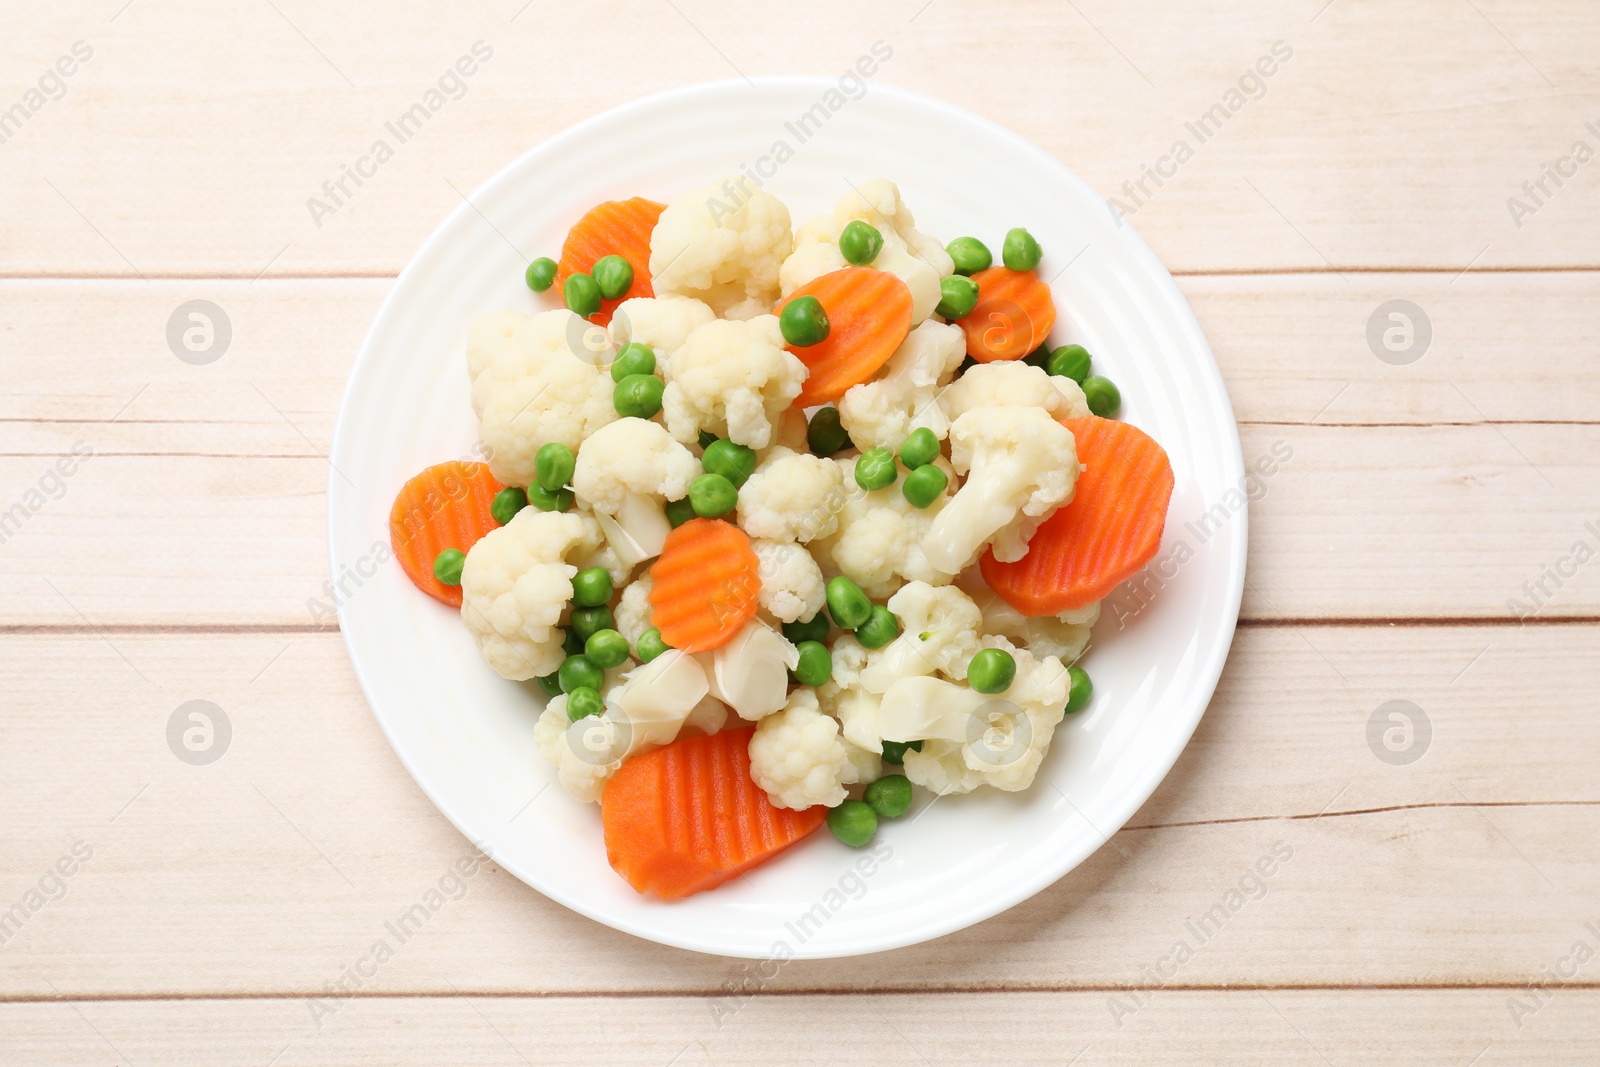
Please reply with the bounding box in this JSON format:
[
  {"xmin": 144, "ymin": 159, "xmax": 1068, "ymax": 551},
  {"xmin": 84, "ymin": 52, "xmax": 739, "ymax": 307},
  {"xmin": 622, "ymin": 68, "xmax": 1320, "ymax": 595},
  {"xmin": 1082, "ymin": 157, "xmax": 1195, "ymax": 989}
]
[{"xmin": 9, "ymin": 0, "xmax": 1600, "ymax": 277}]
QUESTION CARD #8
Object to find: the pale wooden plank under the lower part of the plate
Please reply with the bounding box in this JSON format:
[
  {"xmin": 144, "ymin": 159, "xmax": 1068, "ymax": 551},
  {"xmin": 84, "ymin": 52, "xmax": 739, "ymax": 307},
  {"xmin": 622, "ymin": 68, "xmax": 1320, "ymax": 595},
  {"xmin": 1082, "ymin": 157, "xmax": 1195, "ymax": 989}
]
[{"xmin": 0, "ymin": 627, "xmax": 1600, "ymax": 997}]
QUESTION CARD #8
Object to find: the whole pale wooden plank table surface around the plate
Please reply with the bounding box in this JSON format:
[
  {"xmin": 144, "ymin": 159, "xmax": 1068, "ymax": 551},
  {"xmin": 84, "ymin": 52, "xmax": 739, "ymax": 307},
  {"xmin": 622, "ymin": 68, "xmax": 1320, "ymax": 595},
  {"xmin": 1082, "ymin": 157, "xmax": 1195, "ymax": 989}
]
[{"xmin": 0, "ymin": 0, "xmax": 1600, "ymax": 1067}]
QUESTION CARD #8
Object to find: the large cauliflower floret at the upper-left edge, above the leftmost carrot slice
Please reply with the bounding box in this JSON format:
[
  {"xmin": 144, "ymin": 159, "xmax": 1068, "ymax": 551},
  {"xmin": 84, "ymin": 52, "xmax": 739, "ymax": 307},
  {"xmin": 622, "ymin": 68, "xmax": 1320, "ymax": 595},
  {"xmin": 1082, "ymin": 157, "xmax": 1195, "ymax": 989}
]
[{"xmin": 467, "ymin": 309, "xmax": 616, "ymax": 486}]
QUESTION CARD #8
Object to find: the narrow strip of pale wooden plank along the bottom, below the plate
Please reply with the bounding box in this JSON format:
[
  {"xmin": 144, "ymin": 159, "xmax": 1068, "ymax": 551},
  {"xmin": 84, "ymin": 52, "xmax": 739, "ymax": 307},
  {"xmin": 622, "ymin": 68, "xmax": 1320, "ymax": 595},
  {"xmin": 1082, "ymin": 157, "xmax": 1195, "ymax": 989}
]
[{"xmin": 0, "ymin": 989, "xmax": 1600, "ymax": 1067}]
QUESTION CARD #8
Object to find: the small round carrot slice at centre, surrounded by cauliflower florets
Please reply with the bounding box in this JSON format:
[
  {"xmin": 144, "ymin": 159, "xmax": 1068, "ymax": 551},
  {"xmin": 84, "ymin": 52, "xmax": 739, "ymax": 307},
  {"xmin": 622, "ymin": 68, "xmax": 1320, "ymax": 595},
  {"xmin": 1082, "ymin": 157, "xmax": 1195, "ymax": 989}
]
[{"xmin": 650, "ymin": 518, "xmax": 762, "ymax": 653}]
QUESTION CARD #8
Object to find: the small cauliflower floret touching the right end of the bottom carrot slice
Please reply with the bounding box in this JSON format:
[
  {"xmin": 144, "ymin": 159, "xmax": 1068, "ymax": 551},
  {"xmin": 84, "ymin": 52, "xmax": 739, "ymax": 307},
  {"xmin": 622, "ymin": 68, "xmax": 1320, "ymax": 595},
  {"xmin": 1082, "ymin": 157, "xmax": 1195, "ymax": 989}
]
[{"xmin": 750, "ymin": 688, "xmax": 859, "ymax": 811}]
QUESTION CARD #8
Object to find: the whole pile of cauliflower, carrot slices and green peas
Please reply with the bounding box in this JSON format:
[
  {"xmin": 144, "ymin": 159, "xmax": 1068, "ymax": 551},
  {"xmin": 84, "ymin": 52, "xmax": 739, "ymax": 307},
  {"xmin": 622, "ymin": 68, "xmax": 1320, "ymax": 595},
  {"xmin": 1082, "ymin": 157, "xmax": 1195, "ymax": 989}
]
[{"xmin": 390, "ymin": 179, "xmax": 1173, "ymax": 899}]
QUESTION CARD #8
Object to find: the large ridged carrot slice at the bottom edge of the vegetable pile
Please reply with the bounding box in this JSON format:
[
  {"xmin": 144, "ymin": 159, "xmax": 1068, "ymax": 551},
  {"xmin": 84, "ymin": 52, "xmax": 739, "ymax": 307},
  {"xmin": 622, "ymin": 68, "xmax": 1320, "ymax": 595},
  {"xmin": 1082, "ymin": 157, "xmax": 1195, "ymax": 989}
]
[{"xmin": 600, "ymin": 726, "xmax": 827, "ymax": 901}]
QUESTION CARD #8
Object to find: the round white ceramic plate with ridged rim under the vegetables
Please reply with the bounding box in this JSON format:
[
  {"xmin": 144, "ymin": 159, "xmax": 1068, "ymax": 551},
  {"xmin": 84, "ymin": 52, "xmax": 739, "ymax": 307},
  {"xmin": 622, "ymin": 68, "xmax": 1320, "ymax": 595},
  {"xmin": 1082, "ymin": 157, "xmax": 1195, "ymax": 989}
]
[{"xmin": 328, "ymin": 78, "xmax": 1245, "ymax": 957}]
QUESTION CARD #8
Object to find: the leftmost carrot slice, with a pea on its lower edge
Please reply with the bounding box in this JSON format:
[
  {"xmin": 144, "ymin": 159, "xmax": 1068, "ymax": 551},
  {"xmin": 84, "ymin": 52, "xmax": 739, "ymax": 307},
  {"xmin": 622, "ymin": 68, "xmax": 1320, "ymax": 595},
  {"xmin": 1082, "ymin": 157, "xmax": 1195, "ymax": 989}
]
[{"xmin": 389, "ymin": 461, "xmax": 506, "ymax": 608}]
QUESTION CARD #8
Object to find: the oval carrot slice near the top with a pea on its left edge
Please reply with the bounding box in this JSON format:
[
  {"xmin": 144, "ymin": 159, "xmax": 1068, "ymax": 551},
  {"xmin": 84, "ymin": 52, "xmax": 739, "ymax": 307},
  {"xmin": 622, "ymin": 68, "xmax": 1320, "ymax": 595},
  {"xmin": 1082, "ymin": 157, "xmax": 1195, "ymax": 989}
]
[{"xmin": 773, "ymin": 267, "xmax": 910, "ymax": 408}]
